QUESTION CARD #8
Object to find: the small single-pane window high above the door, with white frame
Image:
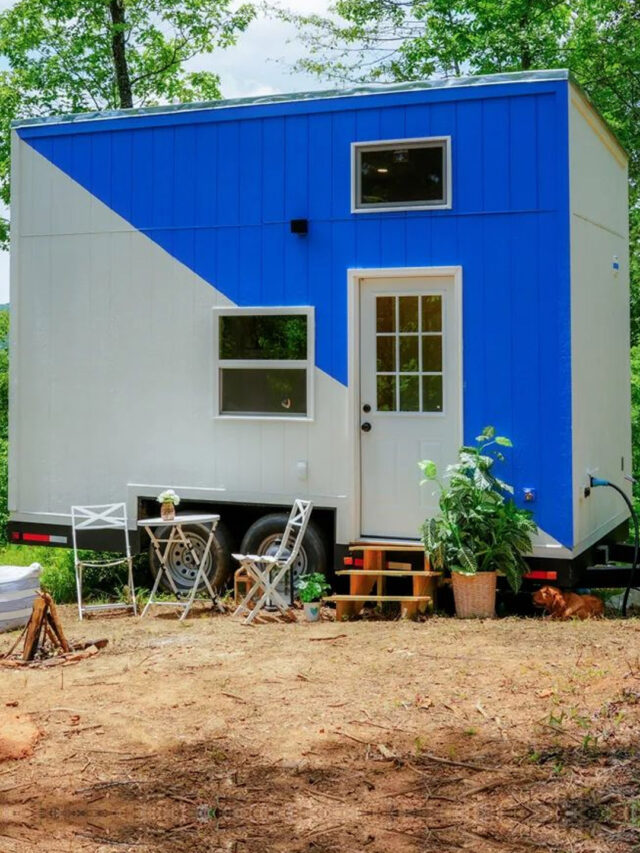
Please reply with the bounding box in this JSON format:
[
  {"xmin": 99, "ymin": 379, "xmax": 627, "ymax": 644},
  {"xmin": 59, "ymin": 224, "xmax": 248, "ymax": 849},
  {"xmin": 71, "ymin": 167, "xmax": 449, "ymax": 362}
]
[{"xmin": 353, "ymin": 137, "xmax": 451, "ymax": 212}]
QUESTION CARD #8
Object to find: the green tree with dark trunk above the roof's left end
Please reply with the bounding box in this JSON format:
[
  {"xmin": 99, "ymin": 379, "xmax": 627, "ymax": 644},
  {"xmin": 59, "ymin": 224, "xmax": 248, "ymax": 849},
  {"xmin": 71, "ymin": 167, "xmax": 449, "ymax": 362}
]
[{"xmin": 0, "ymin": 0, "xmax": 255, "ymax": 244}]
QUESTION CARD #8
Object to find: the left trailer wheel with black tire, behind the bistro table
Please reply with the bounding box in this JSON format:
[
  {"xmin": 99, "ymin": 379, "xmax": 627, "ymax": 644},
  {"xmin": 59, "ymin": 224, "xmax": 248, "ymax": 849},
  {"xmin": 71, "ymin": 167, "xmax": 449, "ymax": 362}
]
[{"xmin": 149, "ymin": 523, "xmax": 231, "ymax": 592}]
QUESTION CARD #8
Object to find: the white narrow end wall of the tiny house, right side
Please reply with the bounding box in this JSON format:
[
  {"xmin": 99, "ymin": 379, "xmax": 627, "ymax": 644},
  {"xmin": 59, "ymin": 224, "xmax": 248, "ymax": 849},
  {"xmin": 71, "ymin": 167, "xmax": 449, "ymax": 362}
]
[{"xmin": 569, "ymin": 89, "xmax": 637, "ymax": 551}]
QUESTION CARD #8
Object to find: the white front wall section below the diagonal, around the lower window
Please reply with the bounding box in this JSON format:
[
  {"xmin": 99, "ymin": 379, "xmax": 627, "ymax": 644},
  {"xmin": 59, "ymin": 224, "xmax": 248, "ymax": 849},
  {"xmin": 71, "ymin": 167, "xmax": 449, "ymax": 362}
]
[{"xmin": 12, "ymin": 143, "xmax": 349, "ymax": 532}]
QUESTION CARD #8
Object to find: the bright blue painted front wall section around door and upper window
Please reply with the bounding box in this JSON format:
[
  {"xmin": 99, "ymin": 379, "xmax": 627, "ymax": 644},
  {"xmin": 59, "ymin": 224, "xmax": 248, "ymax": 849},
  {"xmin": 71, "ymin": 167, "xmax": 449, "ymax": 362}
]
[{"xmin": 19, "ymin": 81, "xmax": 572, "ymax": 546}]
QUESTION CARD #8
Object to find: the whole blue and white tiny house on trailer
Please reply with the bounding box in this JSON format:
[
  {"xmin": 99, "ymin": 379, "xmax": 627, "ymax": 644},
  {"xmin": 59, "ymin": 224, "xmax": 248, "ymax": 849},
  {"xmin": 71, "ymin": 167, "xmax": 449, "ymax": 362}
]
[{"xmin": 10, "ymin": 70, "xmax": 631, "ymax": 577}]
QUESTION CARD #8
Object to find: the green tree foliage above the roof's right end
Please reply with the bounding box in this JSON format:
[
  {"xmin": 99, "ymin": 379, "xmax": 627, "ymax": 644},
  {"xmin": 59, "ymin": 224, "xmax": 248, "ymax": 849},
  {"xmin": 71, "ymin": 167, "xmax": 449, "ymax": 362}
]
[{"xmin": 281, "ymin": 0, "xmax": 640, "ymax": 344}]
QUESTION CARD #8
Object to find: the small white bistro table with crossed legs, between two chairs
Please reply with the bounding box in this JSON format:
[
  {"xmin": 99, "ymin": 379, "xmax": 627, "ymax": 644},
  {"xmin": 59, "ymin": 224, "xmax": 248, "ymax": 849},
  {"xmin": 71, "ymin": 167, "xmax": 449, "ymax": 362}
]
[{"xmin": 138, "ymin": 513, "xmax": 222, "ymax": 620}]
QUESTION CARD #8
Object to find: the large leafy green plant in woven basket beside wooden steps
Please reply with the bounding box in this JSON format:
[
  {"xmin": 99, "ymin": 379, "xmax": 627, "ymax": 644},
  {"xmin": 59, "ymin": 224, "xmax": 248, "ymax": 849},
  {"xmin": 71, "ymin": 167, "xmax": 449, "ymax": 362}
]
[{"xmin": 418, "ymin": 426, "xmax": 538, "ymax": 618}]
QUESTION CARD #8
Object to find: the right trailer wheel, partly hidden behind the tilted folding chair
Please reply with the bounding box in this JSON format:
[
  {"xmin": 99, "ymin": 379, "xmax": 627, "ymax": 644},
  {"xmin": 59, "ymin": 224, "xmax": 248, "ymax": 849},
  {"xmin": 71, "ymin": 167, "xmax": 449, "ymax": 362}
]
[{"xmin": 240, "ymin": 512, "xmax": 327, "ymax": 594}]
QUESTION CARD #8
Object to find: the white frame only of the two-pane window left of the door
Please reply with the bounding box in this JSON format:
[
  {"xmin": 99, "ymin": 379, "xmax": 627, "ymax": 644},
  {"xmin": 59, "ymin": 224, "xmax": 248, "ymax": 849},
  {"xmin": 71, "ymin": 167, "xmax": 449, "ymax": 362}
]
[{"xmin": 213, "ymin": 305, "xmax": 316, "ymax": 423}]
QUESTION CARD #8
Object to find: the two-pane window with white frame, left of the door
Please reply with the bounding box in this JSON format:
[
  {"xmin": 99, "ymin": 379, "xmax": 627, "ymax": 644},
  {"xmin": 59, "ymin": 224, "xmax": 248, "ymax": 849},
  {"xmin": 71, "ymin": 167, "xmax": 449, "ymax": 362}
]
[{"xmin": 215, "ymin": 308, "xmax": 313, "ymax": 418}]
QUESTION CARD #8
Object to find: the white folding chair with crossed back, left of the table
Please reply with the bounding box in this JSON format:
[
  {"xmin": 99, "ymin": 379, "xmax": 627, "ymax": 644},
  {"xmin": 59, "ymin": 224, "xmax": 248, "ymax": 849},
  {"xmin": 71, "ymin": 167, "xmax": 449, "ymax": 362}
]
[{"xmin": 71, "ymin": 503, "xmax": 138, "ymax": 620}]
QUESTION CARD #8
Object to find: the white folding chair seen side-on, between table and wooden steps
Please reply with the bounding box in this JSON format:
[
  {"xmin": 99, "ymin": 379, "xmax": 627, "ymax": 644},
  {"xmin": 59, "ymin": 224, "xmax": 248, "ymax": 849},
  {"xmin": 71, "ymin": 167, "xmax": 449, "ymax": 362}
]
[{"xmin": 233, "ymin": 499, "xmax": 313, "ymax": 624}]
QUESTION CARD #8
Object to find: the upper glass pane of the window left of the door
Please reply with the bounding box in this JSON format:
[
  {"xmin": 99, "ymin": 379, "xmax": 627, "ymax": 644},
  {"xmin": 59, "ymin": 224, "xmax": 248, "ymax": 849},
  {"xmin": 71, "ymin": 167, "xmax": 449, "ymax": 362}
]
[{"xmin": 220, "ymin": 314, "xmax": 307, "ymax": 361}]
